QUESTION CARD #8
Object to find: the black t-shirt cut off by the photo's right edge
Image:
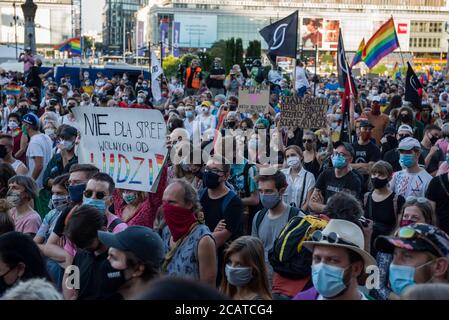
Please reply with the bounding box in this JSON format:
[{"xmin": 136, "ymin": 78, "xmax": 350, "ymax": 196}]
[{"xmin": 426, "ymin": 174, "xmax": 449, "ymax": 234}]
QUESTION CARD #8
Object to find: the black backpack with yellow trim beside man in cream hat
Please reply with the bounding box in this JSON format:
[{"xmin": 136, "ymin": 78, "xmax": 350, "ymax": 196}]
[{"xmin": 268, "ymin": 214, "xmax": 327, "ymax": 279}]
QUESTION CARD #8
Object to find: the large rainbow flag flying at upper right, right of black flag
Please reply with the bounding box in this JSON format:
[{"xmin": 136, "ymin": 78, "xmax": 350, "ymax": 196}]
[{"xmin": 362, "ymin": 17, "xmax": 399, "ymax": 69}]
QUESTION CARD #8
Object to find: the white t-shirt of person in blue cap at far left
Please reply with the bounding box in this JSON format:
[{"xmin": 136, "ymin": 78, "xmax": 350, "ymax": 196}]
[{"xmin": 26, "ymin": 133, "xmax": 53, "ymax": 189}]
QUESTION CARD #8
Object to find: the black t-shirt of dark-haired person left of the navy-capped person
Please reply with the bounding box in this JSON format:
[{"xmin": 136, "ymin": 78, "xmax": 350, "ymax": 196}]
[{"xmin": 73, "ymin": 249, "xmax": 125, "ymax": 300}]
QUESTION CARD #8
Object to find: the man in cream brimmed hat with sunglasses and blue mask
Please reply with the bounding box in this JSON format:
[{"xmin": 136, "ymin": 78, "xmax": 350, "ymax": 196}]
[{"xmin": 293, "ymin": 219, "xmax": 376, "ymax": 300}]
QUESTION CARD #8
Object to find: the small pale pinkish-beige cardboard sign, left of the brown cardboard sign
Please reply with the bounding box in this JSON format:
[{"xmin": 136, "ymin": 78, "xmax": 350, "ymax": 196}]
[{"xmin": 237, "ymin": 87, "xmax": 270, "ymax": 113}]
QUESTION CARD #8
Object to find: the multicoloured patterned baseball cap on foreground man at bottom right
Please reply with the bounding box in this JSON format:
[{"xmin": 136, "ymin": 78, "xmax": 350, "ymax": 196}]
[{"xmin": 374, "ymin": 223, "xmax": 449, "ymax": 257}]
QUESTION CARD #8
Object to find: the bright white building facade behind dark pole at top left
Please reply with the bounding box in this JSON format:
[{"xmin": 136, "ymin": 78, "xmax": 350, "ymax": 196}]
[{"xmin": 0, "ymin": 0, "xmax": 72, "ymax": 50}]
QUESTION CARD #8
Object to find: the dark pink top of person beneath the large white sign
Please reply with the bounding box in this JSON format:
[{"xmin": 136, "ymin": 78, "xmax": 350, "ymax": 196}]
[{"xmin": 112, "ymin": 166, "xmax": 167, "ymax": 228}]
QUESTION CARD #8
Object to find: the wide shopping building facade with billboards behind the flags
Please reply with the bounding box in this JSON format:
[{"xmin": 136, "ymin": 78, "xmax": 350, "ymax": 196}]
[{"xmin": 137, "ymin": 0, "xmax": 449, "ymax": 63}]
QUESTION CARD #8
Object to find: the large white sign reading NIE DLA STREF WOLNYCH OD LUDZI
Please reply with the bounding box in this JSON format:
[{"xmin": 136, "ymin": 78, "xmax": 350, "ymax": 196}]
[{"xmin": 73, "ymin": 107, "xmax": 167, "ymax": 192}]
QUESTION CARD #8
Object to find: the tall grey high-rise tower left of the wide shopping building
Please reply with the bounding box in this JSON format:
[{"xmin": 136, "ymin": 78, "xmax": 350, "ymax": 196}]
[{"xmin": 103, "ymin": 0, "xmax": 148, "ymax": 55}]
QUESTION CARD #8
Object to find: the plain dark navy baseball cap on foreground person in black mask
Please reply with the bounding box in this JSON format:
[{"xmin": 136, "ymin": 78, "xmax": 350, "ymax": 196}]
[{"xmin": 98, "ymin": 226, "xmax": 164, "ymax": 267}]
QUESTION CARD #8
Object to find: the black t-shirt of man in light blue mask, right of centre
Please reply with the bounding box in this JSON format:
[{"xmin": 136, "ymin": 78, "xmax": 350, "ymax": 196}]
[{"xmin": 315, "ymin": 168, "xmax": 362, "ymax": 203}]
